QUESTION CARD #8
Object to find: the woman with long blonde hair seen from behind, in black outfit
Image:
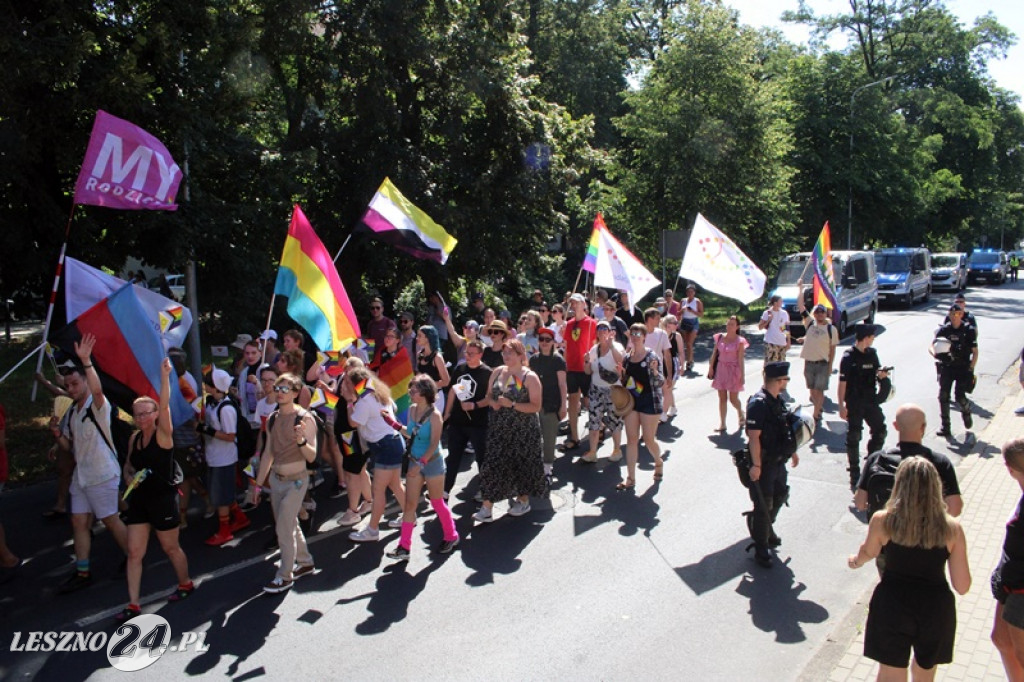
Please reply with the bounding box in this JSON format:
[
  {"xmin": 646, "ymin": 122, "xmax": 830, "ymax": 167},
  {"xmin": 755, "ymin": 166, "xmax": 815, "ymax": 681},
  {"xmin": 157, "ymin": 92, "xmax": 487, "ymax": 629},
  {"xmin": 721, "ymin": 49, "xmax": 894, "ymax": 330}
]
[{"xmin": 847, "ymin": 457, "xmax": 971, "ymax": 682}]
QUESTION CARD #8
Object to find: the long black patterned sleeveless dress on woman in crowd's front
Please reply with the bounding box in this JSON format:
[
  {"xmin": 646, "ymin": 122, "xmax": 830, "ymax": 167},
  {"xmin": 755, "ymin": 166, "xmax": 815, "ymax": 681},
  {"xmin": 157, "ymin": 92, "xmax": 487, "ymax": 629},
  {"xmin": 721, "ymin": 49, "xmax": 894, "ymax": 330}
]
[{"xmin": 480, "ymin": 368, "xmax": 546, "ymax": 501}]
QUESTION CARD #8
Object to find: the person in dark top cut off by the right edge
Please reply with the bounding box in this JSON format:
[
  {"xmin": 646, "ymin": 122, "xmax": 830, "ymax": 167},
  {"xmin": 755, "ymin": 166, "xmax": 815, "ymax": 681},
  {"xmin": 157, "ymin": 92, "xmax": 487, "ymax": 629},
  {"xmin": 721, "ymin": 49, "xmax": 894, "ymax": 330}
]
[{"xmin": 991, "ymin": 438, "xmax": 1024, "ymax": 682}]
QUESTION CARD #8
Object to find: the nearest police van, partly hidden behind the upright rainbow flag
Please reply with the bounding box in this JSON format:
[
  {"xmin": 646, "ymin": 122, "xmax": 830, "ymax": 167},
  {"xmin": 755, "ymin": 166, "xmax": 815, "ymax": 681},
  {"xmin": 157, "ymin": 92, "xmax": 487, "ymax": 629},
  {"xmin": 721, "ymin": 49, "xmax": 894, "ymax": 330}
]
[{"xmin": 772, "ymin": 251, "xmax": 879, "ymax": 338}]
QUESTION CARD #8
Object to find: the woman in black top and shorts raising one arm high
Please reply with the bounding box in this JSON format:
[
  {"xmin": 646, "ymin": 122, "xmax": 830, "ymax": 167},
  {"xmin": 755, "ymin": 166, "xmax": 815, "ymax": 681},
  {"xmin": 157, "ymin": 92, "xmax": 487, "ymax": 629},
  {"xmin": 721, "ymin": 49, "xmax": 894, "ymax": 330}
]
[{"xmin": 119, "ymin": 357, "xmax": 195, "ymax": 621}]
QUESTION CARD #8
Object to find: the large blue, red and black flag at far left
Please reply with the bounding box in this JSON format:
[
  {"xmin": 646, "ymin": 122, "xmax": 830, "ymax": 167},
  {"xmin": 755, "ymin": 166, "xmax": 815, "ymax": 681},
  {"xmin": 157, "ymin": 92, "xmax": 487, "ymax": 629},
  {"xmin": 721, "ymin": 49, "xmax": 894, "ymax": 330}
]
[{"xmin": 50, "ymin": 284, "xmax": 195, "ymax": 426}]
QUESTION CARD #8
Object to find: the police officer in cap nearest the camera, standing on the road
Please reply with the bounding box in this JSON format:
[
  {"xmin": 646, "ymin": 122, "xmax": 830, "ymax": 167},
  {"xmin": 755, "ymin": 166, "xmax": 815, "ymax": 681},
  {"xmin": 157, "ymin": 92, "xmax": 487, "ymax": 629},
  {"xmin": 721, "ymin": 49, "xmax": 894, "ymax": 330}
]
[{"xmin": 746, "ymin": 363, "xmax": 800, "ymax": 568}]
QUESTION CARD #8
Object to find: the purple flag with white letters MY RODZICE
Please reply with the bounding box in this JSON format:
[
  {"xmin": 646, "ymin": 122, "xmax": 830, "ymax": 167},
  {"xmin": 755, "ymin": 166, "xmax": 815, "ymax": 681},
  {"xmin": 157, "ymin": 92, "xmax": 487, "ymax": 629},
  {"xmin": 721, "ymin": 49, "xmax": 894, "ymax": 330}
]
[{"xmin": 74, "ymin": 110, "xmax": 181, "ymax": 211}]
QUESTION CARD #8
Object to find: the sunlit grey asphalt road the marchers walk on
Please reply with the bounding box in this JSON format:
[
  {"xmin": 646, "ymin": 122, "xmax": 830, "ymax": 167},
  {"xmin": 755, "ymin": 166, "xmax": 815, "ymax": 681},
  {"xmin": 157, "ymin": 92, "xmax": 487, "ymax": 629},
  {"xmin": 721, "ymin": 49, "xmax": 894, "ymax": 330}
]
[{"xmin": 0, "ymin": 278, "xmax": 1024, "ymax": 680}]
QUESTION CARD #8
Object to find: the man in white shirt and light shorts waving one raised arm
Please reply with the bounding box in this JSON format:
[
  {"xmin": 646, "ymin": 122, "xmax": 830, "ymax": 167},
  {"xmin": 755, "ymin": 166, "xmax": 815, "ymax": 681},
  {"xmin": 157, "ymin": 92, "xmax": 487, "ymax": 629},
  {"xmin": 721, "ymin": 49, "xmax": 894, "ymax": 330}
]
[{"xmin": 50, "ymin": 334, "xmax": 128, "ymax": 594}]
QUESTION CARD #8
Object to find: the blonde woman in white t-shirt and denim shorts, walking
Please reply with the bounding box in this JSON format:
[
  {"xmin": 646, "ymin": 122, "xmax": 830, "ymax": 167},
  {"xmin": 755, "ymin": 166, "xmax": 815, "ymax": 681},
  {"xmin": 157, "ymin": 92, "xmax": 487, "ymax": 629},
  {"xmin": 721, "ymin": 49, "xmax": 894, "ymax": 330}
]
[{"xmin": 341, "ymin": 367, "xmax": 406, "ymax": 543}]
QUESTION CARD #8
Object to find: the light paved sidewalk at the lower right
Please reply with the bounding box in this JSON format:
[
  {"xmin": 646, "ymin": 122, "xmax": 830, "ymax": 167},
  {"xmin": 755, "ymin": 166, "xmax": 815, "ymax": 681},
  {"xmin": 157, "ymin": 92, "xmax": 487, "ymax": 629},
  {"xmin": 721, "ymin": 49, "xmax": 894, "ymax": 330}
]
[{"xmin": 828, "ymin": 372, "xmax": 1024, "ymax": 682}]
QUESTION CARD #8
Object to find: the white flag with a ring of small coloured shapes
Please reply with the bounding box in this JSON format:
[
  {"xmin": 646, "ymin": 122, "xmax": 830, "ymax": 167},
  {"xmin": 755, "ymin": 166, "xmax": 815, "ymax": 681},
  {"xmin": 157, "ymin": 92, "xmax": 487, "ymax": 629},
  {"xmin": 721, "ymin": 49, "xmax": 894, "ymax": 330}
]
[{"xmin": 679, "ymin": 213, "xmax": 766, "ymax": 303}]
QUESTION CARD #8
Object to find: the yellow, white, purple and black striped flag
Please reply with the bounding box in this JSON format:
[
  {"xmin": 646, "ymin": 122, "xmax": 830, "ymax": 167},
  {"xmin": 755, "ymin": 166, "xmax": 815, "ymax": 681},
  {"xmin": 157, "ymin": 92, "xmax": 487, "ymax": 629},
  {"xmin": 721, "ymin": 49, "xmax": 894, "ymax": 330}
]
[{"xmin": 354, "ymin": 178, "xmax": 459, "ymax": 264}]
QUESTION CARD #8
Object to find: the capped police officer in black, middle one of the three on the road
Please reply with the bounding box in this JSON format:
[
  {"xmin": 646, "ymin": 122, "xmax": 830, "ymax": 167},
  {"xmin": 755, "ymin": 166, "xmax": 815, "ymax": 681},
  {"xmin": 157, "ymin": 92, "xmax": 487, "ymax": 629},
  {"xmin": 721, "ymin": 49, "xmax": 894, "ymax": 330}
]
[{"xmin": 838, "ymin": 325, "xmax": 892, "ymax": 491}]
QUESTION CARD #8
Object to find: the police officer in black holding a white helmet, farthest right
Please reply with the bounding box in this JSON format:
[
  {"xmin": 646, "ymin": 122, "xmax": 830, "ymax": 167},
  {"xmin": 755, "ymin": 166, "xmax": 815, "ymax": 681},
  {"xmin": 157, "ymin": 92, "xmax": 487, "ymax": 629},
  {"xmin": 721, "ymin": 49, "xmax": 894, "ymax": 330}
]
[{"xmin": 932, "ymin": 303, "xmax": 978, "ymax": 438}]
